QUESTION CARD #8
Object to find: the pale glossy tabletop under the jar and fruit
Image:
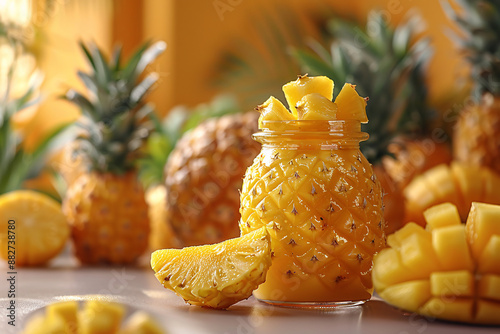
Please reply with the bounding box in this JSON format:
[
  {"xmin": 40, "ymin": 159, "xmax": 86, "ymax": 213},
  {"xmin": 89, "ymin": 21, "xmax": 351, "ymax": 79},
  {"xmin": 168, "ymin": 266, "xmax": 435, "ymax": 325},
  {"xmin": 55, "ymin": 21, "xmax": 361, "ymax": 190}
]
[{"xmin": 0, "ymin": 255, "xmax": 500, "ymax": 334}]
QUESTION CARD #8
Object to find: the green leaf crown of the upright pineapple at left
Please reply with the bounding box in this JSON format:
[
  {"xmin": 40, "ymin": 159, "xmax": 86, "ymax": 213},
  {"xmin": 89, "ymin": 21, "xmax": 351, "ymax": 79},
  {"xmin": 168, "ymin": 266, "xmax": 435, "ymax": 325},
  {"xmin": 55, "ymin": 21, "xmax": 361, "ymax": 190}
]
[{"xmin": 65, "ymin": 42, "xmax": 166, "ymax": 174}]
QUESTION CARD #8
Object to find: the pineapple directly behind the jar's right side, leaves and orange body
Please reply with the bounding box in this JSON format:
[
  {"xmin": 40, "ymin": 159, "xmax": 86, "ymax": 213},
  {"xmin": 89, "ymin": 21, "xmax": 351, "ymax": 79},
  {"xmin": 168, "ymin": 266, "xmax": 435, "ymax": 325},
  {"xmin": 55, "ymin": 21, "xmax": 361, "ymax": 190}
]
[{"xmin": 295, "ymin": 12, "xmax": 450, "ymax": 233}]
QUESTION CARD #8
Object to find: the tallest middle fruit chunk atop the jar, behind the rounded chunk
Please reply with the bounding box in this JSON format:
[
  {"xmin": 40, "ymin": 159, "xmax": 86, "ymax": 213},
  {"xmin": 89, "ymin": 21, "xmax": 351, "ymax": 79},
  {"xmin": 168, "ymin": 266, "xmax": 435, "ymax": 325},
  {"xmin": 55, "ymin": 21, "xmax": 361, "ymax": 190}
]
[{"xmin": 283, "ymin": 74, "xmax": 333, "ymax": 119}]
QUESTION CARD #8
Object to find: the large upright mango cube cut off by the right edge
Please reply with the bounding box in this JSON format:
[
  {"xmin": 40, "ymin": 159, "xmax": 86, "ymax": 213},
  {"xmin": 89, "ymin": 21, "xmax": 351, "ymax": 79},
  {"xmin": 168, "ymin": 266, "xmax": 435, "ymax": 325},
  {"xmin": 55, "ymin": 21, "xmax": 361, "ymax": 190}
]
[{"xmin": 466, "ymin": 203, "xmax": 500, "ymax": 260}]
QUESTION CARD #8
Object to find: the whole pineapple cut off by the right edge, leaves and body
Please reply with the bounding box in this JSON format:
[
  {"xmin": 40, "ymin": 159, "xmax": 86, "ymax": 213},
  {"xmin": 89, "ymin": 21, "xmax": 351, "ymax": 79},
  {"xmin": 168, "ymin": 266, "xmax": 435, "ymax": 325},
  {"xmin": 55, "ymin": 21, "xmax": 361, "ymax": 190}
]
[{"xmin": 444, "ymin": 0, "xmax": 500, "ymax": 173}]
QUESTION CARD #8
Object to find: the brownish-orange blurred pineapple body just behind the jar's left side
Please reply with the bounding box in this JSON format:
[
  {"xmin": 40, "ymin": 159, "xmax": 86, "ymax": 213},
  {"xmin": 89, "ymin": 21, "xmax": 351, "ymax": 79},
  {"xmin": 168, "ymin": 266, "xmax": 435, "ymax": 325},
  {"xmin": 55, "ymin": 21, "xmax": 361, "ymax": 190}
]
[{"xmin": 165, "ymin": 112, "xmax": 260, "ymax": 246}]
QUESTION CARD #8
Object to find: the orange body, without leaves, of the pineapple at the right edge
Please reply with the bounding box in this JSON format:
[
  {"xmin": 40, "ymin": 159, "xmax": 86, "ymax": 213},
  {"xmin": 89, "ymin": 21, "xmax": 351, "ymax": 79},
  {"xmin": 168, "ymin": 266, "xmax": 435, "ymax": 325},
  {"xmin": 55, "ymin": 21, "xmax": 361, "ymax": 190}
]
[{"xmin": 453, "ymin": 93, "xmax": 500, "ymax": 173}]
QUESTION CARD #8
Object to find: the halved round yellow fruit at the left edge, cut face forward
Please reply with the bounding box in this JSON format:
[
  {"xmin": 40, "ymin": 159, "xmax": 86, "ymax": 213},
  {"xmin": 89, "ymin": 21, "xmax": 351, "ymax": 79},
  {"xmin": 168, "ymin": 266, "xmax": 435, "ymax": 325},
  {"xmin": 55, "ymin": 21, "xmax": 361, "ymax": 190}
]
[{"xmin": 0, "ymin": 190, "xmax": 69, "ymax": 266}]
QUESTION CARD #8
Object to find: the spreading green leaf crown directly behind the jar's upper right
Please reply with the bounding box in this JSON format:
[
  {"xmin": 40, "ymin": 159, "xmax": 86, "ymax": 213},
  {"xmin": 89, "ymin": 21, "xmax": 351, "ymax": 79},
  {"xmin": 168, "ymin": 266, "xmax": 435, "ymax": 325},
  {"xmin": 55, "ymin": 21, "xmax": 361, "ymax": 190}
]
[{"xmin": 293, "ymin": 11, "xmax": 433, "ymax": 164}]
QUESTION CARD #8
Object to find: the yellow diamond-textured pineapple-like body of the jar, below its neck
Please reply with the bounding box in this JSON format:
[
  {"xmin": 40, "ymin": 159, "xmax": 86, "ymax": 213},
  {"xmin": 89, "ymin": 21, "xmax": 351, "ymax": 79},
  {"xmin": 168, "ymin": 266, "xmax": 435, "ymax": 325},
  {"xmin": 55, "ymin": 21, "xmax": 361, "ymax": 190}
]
[{"xmin": 240, "ymin": 146, "xmax": 385, "ymax": 302}]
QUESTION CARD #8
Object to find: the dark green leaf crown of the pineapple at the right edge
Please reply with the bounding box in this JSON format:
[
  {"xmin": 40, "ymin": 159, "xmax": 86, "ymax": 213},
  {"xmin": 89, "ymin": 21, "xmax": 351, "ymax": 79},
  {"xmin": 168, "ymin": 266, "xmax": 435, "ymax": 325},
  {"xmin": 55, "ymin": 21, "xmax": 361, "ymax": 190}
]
[{"xmin": 441, "ymin": 0, "xmax": 500, "ymax": 101}]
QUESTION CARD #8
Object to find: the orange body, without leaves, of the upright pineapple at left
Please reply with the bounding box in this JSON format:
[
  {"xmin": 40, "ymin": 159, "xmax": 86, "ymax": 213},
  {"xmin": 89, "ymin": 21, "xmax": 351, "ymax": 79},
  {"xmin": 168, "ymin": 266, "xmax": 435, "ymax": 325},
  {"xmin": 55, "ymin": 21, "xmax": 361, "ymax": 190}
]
[{"xmin": 63, "ymin": 172, "xmax": 149, "ymax": 264}]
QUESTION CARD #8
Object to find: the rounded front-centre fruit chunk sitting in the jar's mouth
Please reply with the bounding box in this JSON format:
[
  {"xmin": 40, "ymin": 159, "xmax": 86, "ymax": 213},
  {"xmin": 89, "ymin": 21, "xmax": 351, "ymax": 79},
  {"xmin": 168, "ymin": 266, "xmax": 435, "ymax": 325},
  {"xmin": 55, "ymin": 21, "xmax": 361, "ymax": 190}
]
[{"xmin": 295, "ymin": 93, "xmax": 337, "ymax": 121}]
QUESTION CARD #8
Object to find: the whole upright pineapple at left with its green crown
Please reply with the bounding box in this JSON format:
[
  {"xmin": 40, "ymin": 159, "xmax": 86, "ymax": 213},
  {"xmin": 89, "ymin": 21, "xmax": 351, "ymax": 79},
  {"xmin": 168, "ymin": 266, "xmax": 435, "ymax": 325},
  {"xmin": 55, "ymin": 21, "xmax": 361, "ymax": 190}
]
[{"xmin": 63, "ymin": 42, "xmax": 165, "ymax": 264}]
